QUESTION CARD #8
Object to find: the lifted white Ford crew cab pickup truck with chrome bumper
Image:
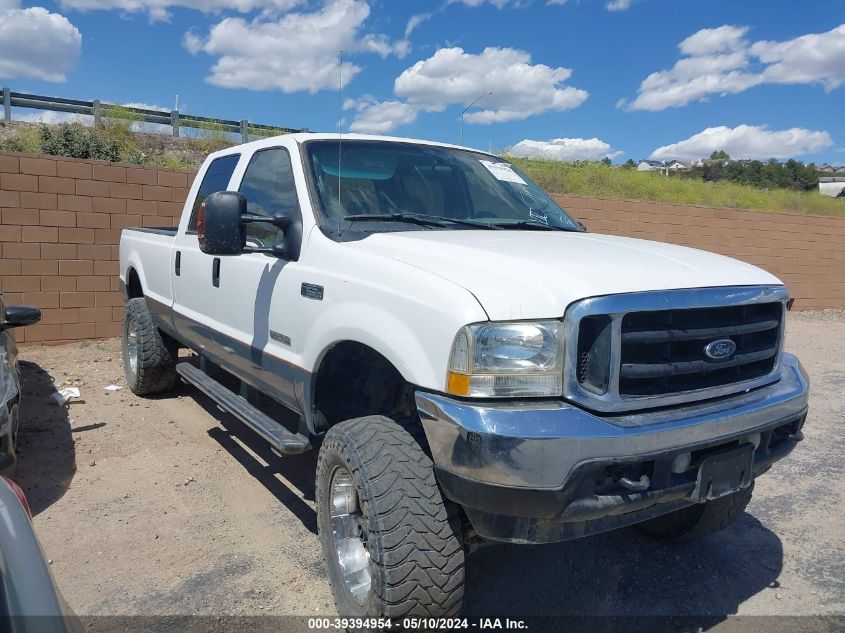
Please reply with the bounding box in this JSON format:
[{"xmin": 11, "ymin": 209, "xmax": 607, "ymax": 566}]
[{"xmin": 120, "ymin": 134, "xmax": 808, "ymax": 618}]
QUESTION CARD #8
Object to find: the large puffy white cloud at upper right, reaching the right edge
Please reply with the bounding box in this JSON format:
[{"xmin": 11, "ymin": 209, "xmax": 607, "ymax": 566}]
[{"xmin": 617, "ymin": 24, "xmax": 845, "ymax": 111}]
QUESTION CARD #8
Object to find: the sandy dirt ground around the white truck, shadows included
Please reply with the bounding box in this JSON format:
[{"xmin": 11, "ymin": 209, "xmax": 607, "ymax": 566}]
[{"xmin": 8, "ymin": 312, "xmax": 845, "ymax": 616}]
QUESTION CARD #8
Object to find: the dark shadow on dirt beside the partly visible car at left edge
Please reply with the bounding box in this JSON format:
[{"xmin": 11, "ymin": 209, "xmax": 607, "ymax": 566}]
[{"xmin": 12, "ymin": 360, "xmax": 76, "ymax": 516}]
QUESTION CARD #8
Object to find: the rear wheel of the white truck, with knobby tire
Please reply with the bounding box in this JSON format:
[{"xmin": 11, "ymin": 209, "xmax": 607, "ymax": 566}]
[{"xmin": 123, "ymin": 297, "xmax": 177, "ymax": 396}]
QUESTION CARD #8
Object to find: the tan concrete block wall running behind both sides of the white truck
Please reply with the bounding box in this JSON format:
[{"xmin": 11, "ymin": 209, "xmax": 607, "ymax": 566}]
[{"xmin": 0, "ymin": 153, "xmax": 845, "ymax": 343}]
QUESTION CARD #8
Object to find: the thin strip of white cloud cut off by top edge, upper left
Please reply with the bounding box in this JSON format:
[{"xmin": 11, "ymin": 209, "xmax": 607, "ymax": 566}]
[{"xmin": 59, "ymin": 0, "xmax": 305, "ymax": 21}]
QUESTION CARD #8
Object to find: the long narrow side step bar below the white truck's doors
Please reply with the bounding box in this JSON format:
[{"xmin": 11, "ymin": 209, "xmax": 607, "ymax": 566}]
[{"xmin": 176, "ymin": 363, "xmax": 311, "ymax": 455}]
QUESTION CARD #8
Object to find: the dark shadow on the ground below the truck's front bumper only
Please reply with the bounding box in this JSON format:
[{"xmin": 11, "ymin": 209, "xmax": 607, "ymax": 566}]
[{"xmin": 464, "ymin": 513, "xmax": 783, "ymax": 630}]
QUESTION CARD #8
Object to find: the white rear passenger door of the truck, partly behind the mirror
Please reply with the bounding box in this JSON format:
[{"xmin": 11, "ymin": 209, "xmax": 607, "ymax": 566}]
[{"xmin": 170, "ymin": 153, "xmax": 241, "ymax": 350}]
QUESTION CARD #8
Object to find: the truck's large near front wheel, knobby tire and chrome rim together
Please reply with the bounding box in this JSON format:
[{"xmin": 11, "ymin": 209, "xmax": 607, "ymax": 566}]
[{"xmin": 316, "ymin": 416, "xmax": 464, "ymax": 620}]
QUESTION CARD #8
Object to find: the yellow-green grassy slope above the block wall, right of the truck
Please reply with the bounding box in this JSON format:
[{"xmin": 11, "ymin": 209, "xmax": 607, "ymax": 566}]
[{"xmin": 508, "ymin": 158, "xmax": 845, "ymax": 217}]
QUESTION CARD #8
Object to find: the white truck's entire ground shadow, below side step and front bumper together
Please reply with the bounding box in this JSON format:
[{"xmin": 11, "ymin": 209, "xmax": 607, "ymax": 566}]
[{"xmin": 166, "ymin": 358, "xmax": 783, "ymax": 630}]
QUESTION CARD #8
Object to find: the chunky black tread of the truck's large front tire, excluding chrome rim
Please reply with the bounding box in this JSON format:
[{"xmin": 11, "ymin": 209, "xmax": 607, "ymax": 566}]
[{"xmin": 318, "ymin": 416, "xmax": 464, "ymax": 618}]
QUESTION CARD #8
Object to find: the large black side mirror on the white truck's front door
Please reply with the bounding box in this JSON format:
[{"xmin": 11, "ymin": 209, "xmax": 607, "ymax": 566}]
[{"xmin": 197, "ymin": 191, "xmax": 246, "ymax": 255}]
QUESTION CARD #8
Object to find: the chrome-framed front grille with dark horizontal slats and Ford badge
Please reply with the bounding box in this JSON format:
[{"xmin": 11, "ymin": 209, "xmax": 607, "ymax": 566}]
[{"xmin": 564, "ymin": 286, "xmax": 789, "ymax": 412}]
